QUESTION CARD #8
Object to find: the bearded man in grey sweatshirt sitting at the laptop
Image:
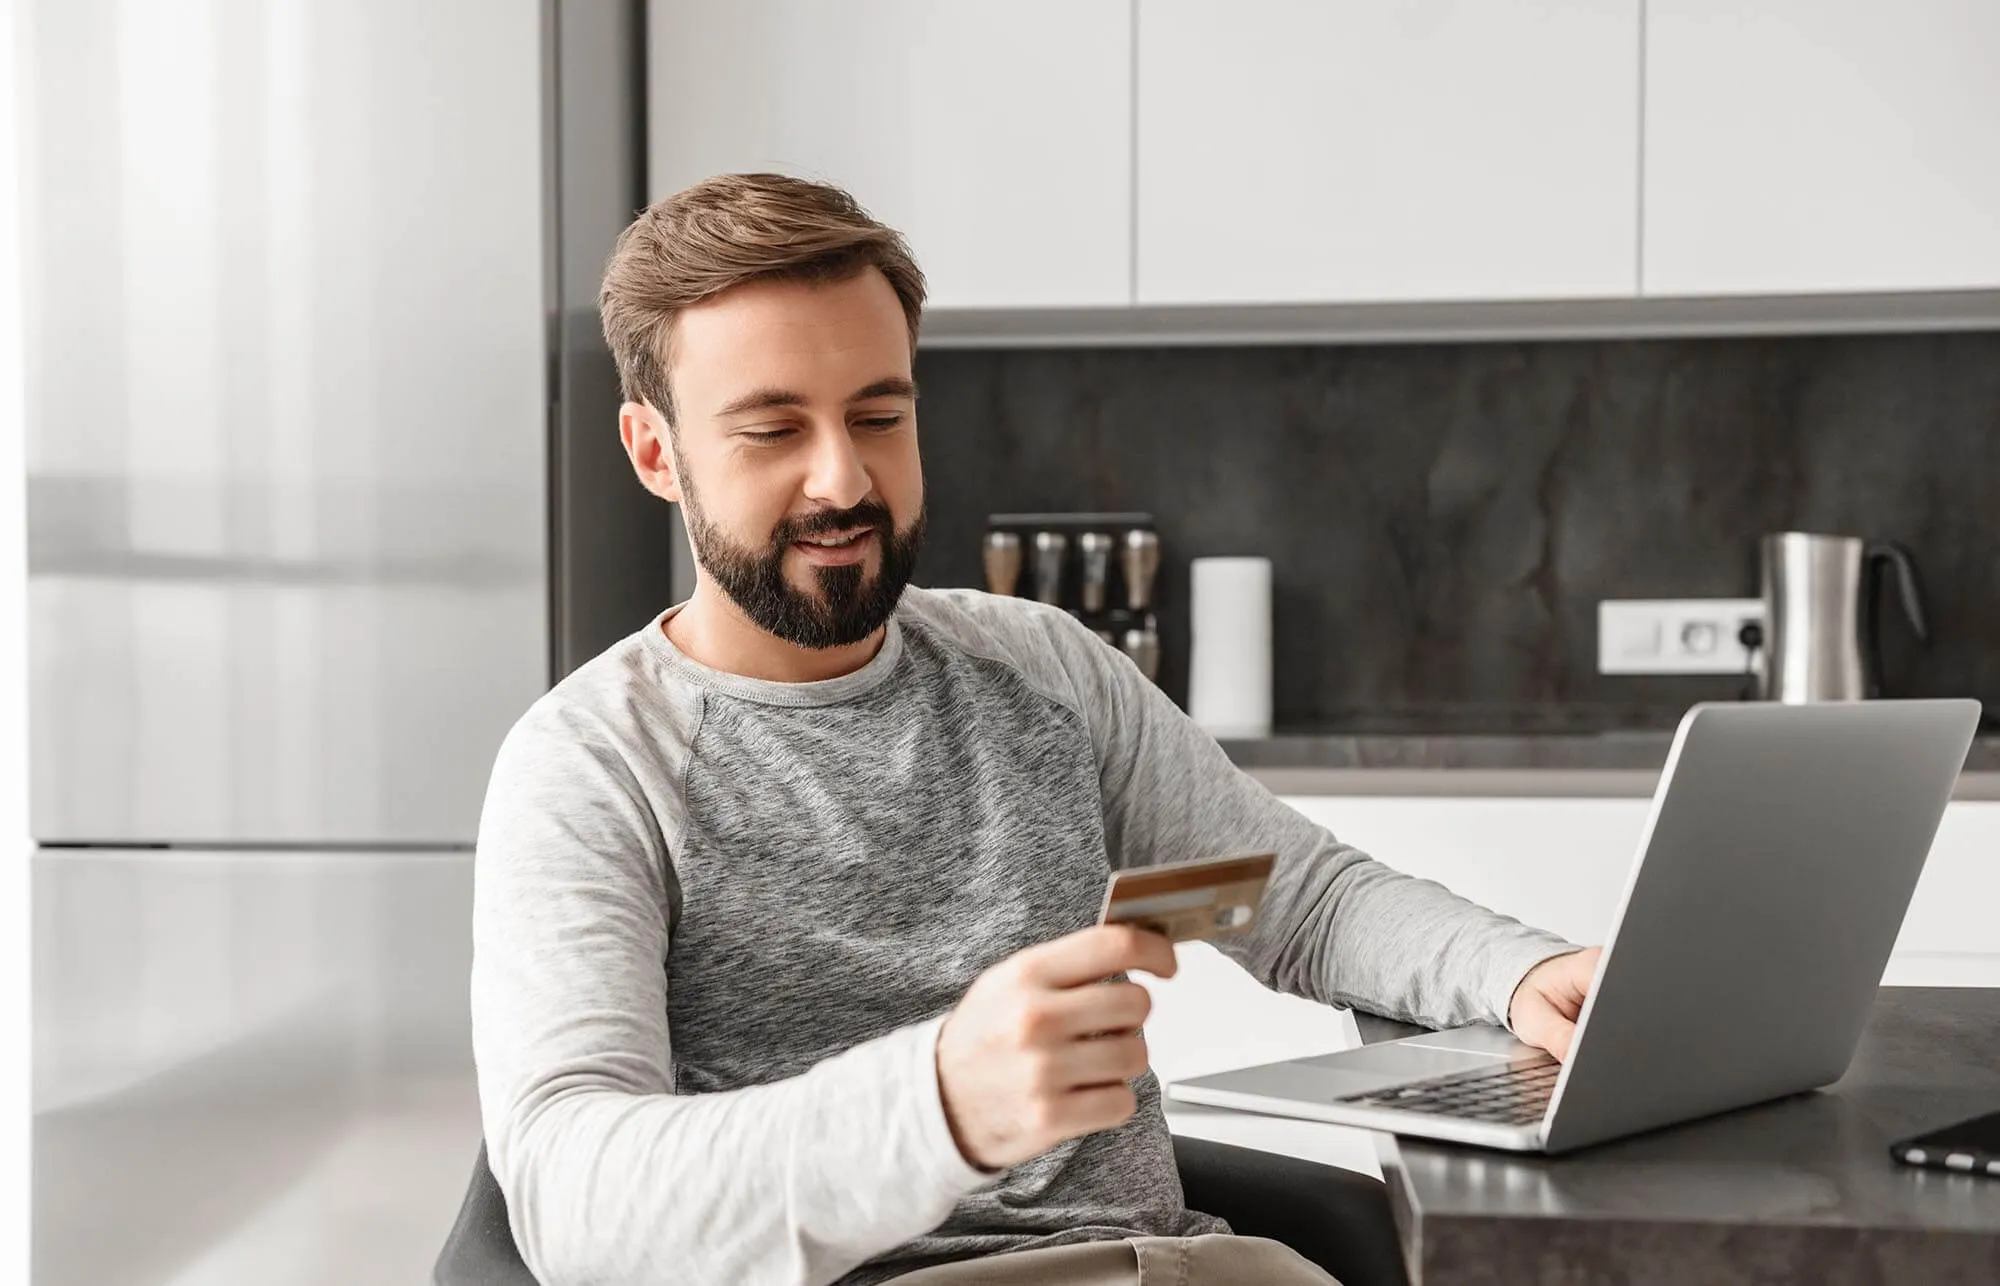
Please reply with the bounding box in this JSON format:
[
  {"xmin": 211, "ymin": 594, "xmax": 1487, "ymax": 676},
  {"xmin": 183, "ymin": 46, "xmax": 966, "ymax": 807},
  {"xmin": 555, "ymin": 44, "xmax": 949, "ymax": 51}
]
[{"xmin": 472, "ymin": 174, "xmax": 1594, "ymax": 1286}]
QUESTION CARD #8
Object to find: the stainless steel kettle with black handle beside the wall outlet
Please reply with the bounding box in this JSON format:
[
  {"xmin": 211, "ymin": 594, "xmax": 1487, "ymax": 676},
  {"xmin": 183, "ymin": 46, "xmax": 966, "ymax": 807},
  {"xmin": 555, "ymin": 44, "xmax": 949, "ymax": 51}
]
[{"xmin": 1758, "ymin": 532, "xmax": 1928, "ymax": 704}]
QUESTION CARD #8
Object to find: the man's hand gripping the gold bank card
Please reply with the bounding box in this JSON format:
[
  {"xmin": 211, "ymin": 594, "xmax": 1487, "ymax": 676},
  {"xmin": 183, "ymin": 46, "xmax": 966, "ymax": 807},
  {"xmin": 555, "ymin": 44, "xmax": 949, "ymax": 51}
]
[{"xmin": 938, "ymin": 924, "xmax": 1176, "ymax": 1170}]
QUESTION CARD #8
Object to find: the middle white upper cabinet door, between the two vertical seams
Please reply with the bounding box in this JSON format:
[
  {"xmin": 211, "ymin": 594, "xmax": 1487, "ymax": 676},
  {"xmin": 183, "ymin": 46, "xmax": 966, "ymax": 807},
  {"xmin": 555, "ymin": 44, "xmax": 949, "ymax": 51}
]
[{"xmin": 1138, "ymin": 0, "xmax": 1640, "ymax": 304}]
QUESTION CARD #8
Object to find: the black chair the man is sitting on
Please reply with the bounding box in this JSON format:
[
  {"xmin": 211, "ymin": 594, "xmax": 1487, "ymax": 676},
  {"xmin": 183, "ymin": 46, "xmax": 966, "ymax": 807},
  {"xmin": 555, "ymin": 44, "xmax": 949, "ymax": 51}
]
[{"xmin": 432, "ymin": 1138, "xmax": 1408, "ymax": 1286}]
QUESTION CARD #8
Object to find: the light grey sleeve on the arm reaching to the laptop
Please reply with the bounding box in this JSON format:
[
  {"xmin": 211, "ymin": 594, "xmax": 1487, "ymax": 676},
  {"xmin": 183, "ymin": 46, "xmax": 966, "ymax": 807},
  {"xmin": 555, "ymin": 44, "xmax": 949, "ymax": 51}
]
[{"xmin": 1072, "ymin": 628, "xmax": 1576, "ymax": 1026}]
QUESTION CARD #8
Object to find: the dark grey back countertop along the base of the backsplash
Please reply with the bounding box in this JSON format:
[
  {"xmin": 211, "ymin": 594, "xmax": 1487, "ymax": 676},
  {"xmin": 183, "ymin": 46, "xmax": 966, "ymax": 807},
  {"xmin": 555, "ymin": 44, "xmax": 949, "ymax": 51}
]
[{"xmin": 1222, "ymin": 720, "xmax": 2000, "ymax": 800}]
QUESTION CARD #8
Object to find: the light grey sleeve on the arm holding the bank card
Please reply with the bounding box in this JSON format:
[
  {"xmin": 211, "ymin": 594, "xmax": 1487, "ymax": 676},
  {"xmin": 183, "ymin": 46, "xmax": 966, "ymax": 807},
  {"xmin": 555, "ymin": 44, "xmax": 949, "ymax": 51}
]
[{"xmin": 472, "ymin": 712, "xmax": 990, "ymax": 1286}]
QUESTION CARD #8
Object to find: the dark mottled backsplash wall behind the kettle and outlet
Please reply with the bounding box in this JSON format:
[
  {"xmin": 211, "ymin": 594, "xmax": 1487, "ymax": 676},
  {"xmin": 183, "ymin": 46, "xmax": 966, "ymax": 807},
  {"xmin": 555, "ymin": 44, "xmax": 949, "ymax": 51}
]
[{"xmin": 916, "ymin": 334, "xmax": 2000, "ymax": 728}]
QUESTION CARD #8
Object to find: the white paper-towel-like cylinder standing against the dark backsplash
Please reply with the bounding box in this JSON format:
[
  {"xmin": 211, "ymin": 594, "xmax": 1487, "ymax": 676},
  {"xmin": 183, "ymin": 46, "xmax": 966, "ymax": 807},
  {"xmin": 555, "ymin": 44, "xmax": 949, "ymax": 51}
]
[{"xmin": 1188, "ymin": 558, "xmax": 1270, "ymax": 736}]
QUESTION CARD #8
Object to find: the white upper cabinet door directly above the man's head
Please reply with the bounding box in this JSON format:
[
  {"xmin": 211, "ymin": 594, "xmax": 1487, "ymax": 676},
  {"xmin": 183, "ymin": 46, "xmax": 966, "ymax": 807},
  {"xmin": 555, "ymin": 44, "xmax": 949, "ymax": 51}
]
[{"xmin": 646, "ymin": 0, "xmax": 1132, "ymax": 308}]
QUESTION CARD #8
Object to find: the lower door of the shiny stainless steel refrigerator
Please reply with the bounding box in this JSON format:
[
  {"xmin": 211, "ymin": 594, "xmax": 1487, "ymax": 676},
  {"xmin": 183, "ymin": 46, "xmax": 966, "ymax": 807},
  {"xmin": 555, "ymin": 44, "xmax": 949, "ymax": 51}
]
[{"xmin": 32, "ymin": 850, "xmax": 480, "ymax": 1286}]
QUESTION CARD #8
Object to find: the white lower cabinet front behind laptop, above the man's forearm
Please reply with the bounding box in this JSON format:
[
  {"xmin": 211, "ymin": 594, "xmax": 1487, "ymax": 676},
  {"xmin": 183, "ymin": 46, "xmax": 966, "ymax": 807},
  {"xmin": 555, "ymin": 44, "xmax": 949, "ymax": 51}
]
[{"xmin": 1286, "ymin": 796, "xmax": 2000, "ymax": 986}]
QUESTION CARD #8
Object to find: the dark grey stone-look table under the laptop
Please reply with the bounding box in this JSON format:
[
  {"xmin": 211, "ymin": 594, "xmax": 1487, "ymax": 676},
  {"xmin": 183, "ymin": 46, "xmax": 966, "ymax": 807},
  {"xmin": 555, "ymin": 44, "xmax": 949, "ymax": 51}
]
[{"xmin": 1356, "ymin": 988, "xmax": 2000, "ymax": 1286}]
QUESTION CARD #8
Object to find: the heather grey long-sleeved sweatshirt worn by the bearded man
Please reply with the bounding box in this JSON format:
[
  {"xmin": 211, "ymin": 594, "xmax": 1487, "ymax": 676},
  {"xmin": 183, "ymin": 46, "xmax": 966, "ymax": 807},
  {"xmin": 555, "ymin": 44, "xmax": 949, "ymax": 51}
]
[{"xmin": 472, "ymin": 588, "xmax": 1570, "ymax": 1286}]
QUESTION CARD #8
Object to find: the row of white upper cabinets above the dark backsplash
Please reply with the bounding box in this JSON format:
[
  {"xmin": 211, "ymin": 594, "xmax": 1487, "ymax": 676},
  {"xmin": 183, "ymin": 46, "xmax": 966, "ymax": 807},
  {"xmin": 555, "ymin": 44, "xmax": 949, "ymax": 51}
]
[{"xmin": 648, "ymin": 0, "xmax": 2000, "ymax": 332}]
